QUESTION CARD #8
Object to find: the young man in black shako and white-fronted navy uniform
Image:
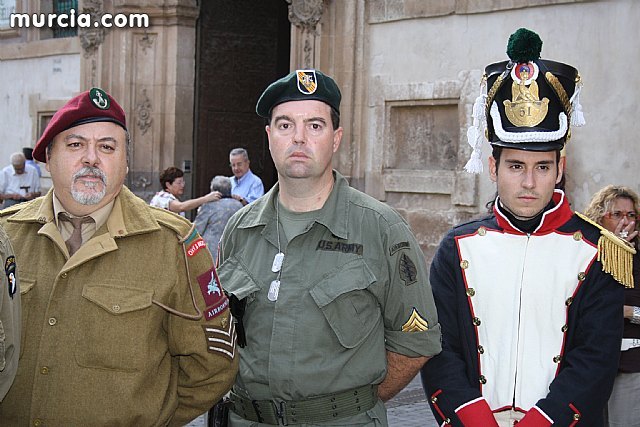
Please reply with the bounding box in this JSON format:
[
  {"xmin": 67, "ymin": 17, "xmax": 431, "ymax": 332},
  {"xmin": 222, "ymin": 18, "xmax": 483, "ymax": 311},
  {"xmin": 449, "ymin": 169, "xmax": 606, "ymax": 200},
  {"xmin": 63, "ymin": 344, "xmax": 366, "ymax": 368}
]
[{"xmin": 422, "ymin": 29, "xmax": 632, "ymax": 427}]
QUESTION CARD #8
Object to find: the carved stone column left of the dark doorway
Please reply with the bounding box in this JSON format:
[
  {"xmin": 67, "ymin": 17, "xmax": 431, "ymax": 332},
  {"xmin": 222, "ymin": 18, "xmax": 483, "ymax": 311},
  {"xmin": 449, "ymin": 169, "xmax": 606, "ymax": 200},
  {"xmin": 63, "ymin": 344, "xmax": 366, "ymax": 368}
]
[{"xmin": 80, "ymin": 0, "xmax": 199, "ymax": 200}]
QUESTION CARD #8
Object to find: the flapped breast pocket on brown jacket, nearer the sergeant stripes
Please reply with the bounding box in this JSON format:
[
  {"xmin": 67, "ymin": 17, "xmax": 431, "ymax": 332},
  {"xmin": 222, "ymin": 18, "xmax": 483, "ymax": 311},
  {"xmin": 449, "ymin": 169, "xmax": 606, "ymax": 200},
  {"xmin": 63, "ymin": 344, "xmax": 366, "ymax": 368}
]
[{"xmin": 76, "ymin": 284, "xmax": 154, "ymax": 372}]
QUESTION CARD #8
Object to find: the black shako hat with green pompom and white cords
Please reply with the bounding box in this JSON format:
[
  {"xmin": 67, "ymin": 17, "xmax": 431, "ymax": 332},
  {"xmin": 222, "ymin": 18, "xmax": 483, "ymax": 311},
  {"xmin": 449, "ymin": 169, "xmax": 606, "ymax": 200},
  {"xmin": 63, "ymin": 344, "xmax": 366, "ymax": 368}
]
[{"xmin": 465, "ymin": 28, "xmax": 584, "ymax": 172}]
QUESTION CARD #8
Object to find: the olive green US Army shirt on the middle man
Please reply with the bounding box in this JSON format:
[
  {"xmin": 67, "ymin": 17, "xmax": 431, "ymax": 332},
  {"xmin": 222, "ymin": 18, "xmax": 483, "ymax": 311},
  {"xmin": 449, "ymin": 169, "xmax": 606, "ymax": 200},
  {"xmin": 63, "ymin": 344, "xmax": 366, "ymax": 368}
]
[{"xmin": 219, "ymin": 172, "xmax": 441, "ymax": 425}]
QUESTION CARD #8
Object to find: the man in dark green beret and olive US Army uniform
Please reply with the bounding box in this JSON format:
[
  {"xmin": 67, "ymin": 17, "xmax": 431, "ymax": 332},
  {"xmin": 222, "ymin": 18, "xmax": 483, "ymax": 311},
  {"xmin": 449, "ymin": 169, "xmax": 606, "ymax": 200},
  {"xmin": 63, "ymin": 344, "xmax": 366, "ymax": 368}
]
[{"xmin": 219, "ymin": 70, "xmax": 440, "ymax": 426}]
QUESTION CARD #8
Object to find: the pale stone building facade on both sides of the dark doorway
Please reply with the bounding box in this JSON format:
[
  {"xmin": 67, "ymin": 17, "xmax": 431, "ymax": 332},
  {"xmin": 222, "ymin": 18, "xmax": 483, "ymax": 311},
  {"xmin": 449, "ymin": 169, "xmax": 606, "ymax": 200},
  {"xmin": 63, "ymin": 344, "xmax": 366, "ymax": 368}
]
[{"xmin": 0, "ymin": 0, "xmax": 640, "ymax": 264}]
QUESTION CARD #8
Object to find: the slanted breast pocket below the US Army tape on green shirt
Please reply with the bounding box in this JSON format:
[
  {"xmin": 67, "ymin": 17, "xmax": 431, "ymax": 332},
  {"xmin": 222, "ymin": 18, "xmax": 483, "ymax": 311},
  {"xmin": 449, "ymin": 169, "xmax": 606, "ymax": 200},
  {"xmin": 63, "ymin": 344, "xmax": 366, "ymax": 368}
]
[{"xmin": 309, "ymin": 259, "xmax": 382, "ymax": 348}]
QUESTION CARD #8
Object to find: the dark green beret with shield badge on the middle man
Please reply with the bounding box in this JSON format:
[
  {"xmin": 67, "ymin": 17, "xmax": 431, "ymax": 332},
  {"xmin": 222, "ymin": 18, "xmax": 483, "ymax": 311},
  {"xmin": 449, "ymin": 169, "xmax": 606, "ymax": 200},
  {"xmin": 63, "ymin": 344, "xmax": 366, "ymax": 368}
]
[{"xmin": 256, "ymin": 70, "xmax": 342, "ymax": 118}]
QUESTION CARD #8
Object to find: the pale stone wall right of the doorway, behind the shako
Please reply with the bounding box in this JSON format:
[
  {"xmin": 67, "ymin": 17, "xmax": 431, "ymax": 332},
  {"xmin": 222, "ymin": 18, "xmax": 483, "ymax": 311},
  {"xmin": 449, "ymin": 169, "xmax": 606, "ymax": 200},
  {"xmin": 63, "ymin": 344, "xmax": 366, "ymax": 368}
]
[{"xmin": 306, "ymin": 0, "xmax": 640, "ymax": 259}]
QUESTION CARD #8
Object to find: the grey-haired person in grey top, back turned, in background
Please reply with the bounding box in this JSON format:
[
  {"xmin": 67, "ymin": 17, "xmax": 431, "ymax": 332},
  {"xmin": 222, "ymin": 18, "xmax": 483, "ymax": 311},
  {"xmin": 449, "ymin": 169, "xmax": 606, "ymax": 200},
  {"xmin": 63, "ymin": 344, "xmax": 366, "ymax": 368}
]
[{"xmin": 194, "ymin": 175, "xmax": 242, "ymax": 253}]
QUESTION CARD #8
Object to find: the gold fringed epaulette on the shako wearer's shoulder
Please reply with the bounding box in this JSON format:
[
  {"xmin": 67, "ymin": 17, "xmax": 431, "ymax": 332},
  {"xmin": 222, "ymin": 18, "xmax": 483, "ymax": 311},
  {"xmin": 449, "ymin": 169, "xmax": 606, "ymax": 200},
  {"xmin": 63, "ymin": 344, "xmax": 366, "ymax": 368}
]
[{"xmin": 576, "ymin": 212, "xmax": 636, "ymax": 288}]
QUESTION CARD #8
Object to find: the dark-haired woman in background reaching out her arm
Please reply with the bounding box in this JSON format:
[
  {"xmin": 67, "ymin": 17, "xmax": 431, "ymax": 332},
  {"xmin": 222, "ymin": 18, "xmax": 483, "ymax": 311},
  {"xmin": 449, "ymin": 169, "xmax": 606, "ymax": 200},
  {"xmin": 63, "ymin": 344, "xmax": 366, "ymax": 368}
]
[{"xmin": 149, "ymin": 166, "xmax": 220, "ymax": 216}]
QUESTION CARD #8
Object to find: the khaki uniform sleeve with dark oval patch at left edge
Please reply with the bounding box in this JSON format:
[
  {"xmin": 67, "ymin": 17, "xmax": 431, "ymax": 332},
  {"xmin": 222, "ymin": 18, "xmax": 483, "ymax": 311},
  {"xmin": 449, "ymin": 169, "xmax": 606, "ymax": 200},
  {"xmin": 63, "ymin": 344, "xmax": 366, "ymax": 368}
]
[{"xmin": 0, "ymin": 227, "xmax": 20, "ymax": 402}]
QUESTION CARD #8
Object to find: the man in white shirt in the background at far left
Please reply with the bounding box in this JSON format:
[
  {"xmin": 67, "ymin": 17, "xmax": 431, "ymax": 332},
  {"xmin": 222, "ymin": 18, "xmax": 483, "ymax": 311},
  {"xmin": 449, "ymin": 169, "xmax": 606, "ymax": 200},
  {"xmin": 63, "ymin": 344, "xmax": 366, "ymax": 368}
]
[{"xmin": 0, "ymin": 153, "xmax": 40, "ymax": 208}]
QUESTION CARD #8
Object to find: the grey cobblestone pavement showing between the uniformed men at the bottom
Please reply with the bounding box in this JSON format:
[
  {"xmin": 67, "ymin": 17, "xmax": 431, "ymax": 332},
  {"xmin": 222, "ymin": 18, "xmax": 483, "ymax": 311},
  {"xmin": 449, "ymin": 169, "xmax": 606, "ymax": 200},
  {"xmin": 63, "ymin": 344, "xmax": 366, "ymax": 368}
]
[{"xmin": 182, "ymin": 376, "xmax": 437, "ymax": 427}]
